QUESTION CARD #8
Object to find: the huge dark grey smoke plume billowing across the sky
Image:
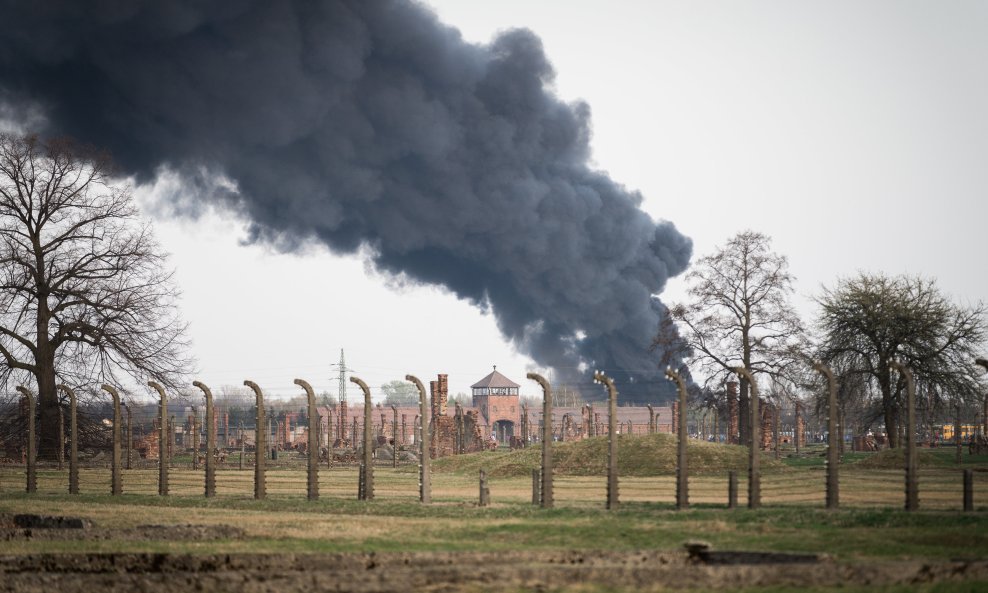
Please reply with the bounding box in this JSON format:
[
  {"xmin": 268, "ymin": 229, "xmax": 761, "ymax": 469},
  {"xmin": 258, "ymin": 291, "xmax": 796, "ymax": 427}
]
[{"xmin": 0, "ymin": 0, "xmax": 691, "ymax": 395}]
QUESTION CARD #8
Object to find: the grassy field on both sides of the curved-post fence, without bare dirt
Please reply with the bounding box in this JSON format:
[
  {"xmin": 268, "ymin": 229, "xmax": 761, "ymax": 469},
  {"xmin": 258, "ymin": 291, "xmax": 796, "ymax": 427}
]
[{"xmin": 0, "ymin": 439, "xmax": 988, "ymax": 593}]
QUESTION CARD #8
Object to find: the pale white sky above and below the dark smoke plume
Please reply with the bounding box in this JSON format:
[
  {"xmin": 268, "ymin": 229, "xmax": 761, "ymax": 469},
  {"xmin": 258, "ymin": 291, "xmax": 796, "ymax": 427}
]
[{"xmin": 139, "ymin": 0, "xmax": 988, "ymax": 401}]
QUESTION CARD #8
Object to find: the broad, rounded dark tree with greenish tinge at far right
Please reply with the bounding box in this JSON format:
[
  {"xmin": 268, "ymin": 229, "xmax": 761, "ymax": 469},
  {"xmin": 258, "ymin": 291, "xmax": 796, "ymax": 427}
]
[{"xmin": 818, "ymin": 273, "xmax": 986, "ymax": 447}]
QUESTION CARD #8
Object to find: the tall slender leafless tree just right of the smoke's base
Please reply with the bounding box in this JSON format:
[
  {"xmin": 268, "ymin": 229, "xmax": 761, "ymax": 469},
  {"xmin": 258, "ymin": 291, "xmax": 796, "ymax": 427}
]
[{"xmin": 657, "ymin": 231, "xmax": 805, "ymax": 442}]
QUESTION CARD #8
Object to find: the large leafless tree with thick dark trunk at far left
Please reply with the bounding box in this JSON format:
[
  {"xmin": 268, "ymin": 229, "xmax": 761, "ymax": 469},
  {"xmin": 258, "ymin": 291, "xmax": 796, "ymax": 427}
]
[{"xmin": 0, "ymin": 134, "xmax": 191, "ymax": 456}]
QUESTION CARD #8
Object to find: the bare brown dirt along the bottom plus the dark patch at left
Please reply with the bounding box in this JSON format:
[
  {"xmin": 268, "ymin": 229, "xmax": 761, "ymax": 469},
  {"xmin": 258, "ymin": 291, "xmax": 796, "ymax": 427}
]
[{"xmin": 0, "ymin": 513, "xmax": 988, "ymax": 593}]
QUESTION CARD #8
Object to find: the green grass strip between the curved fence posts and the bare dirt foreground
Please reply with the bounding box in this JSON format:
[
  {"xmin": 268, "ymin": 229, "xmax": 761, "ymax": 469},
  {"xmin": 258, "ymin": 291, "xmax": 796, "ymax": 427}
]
[{"xmin": 0, "ymin": 476, "xmax": 988, "ymax": 562}]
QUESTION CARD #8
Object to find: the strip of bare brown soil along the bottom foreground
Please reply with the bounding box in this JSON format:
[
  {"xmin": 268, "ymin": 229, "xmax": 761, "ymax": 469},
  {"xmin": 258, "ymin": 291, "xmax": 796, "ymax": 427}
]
[{"xmin": 0, "ymin": 551, "xmax": 988, "ymax": 593}]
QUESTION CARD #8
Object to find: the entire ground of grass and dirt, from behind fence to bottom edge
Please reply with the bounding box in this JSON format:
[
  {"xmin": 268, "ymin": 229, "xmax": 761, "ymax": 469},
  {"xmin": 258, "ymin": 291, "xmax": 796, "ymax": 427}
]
[{"xmin": 0, "ymin": 444, "xmax": 988, "ymax": 593}]
